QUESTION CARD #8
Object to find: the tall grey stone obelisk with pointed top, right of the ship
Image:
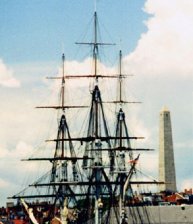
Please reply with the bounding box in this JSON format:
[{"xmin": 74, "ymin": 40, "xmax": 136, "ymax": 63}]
[{"xmin": 159, "ymin": 107, "xmax": 177, "ymax": 192}]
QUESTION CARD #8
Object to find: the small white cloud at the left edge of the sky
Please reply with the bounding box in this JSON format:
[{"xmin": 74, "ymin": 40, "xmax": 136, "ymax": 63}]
[{"xmin": 0, "ymin": 59, "xmax": 20, "ymax": 87}]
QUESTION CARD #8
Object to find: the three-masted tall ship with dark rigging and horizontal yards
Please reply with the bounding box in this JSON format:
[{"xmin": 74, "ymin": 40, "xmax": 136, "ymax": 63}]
[{"xmin": 8, "ymin": 7, "xmax": 191, "ymax": 224}]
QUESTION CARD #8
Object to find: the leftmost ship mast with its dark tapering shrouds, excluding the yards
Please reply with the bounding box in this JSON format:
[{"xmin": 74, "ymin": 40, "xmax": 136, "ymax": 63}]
[{"xmin": 50, "ymin": 54, "xmax": 80, "ymax": 214}]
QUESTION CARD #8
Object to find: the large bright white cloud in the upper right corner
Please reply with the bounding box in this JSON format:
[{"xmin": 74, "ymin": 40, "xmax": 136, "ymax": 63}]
[{"xmin": 125, "ymin": 0, "xmax": 193, "ymax": 78}]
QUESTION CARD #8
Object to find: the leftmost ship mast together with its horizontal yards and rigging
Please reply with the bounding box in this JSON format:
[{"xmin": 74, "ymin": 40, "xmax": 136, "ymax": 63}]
[{"xmin": 9, "ymin": 54, "xmax": 85, "ymax": 222}]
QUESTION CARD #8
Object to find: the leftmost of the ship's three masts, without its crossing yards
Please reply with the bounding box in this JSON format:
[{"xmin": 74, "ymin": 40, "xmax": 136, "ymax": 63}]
[{"xmin": 50, "ymin": 54, "xmax": 78, "ymax": 210}]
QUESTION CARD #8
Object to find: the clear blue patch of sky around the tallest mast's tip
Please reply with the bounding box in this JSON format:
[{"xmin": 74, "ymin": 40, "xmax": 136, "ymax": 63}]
[{"xmin": 0, "ymin": 0, "xmax": 147, "ymax": 63}]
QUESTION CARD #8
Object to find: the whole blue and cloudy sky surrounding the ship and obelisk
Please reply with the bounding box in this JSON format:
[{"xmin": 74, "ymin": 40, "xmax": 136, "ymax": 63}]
[{"xmin": 0, "ymin": 0, "xmax": 193, "ymax": 205}]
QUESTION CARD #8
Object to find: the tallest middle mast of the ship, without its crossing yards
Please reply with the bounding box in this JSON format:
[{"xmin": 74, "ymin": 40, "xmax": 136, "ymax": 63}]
[{"xmin": 83, "ymin": 11, "xmax": 112, "ymax": 224}]
